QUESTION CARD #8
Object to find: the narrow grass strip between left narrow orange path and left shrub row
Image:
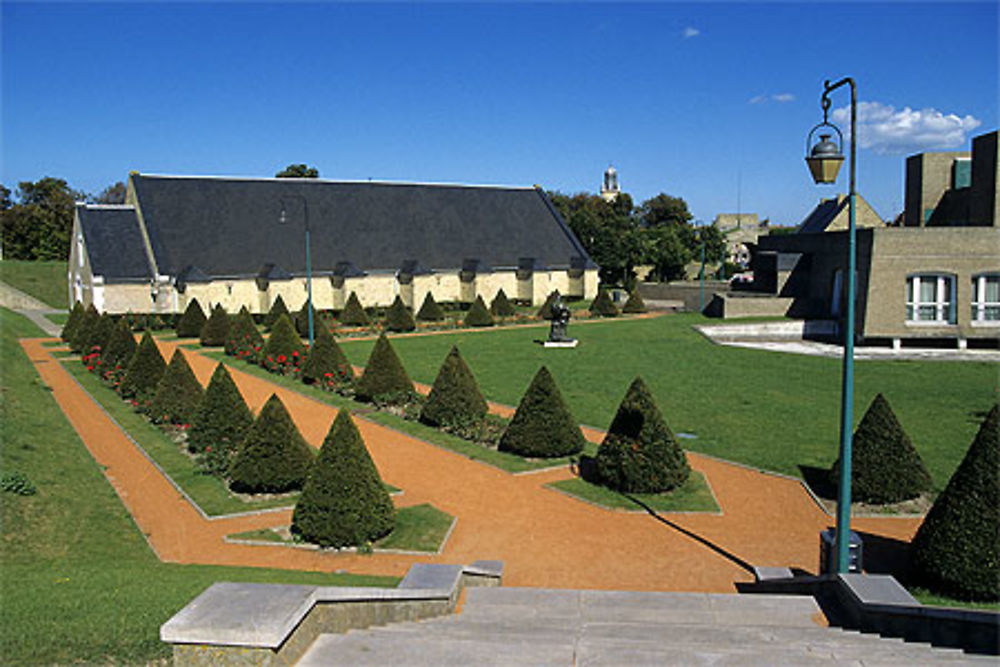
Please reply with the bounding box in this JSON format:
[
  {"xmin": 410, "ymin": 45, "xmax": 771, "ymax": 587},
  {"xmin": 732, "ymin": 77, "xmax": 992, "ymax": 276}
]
[{"xmin": 63, "ymin": 359, "xmax": 299, "ymax": 516}]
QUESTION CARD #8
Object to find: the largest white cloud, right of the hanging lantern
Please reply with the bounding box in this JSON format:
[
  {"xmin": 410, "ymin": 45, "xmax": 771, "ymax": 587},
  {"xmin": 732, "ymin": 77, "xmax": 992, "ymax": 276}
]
[{"xmin": 833, "ymin": 102, "xmax": 983, "ymax": 153}]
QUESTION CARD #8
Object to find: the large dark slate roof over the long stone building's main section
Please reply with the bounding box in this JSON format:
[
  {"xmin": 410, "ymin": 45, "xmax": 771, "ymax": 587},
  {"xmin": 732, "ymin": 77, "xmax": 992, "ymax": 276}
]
[{"xmin": 132, "ymin": 174, "xmax": 594, "ymax": 277}]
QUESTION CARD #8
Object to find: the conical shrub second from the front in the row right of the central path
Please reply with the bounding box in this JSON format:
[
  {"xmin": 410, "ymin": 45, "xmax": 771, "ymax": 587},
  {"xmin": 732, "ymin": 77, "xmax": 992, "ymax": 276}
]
[{"xmin": 499, "ymin": 366, "xmax": 584, "ymax": 458}]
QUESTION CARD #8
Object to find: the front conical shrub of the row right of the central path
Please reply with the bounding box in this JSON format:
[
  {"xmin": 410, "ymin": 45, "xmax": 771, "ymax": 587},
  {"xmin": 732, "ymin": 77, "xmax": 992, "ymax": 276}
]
[{"xmin": 596, "ymin": 378, "xmax": 691, "ymax": 493}]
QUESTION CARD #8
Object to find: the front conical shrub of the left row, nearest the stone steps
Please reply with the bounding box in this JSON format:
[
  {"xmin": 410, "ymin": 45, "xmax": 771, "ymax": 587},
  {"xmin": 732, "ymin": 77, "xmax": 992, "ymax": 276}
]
[{"xmin": 292, "ymin": 410, "xmax": 396, "ymax": 548}]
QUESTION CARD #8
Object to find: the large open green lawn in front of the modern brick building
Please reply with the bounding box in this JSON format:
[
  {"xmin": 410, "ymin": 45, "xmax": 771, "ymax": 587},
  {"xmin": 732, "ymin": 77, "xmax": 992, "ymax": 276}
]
[{"xmin": 341, "ymin": 314, "xmax": 1000, "ymax": 490}]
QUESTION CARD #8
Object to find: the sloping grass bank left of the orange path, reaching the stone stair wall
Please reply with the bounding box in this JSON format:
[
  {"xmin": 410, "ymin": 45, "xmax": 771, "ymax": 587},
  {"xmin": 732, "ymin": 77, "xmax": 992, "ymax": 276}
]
[{"xmin": 0, "ymin": 309, "xmax": 398, "ymax": 664}]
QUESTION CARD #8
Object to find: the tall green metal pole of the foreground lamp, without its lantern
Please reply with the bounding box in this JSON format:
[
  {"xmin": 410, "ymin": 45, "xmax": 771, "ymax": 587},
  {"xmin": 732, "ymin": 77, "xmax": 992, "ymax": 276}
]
[{"xmin": 823, "ymin": 77, "xmax": 858, "ymax": 573}]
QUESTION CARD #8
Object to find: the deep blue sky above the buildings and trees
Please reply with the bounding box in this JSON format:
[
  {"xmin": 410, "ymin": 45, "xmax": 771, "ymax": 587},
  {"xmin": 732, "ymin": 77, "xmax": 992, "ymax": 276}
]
[{"xmin": 0, "ymin": 0, "xmax": 998, "ymax": 224}]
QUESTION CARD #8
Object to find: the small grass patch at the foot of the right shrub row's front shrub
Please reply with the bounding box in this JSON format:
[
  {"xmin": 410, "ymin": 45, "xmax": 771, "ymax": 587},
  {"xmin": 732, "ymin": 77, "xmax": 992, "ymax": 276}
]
[{"xmin": 546, "ymin": 470, "xmax": 719, "ymax": 512}]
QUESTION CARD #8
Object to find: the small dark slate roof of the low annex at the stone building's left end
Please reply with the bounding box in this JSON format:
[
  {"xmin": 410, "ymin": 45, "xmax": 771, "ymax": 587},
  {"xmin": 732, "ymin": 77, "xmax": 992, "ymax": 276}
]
[{"xmin": 76, "ymin": 204, "xmax": 153, "ymax": 282}]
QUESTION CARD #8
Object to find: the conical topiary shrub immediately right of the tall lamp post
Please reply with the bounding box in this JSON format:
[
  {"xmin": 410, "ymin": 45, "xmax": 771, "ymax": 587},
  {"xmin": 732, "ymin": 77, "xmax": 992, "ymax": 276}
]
[{"xmin": 830, "ymin": 394, "xmax": 931, "ymax": 505}]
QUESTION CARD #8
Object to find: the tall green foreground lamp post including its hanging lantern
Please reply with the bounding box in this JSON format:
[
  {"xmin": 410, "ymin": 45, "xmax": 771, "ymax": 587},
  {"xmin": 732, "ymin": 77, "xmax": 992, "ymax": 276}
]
[{"xmin": 806, "ymin": 77, "xmax": 858, "ymax": 573}]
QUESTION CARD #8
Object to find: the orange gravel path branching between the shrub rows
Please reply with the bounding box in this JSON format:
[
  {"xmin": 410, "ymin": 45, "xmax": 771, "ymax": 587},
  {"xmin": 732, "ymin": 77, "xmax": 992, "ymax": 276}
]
[{"xmin": 21, "ymin": 339, "xmax": 919, "ymax": 592}]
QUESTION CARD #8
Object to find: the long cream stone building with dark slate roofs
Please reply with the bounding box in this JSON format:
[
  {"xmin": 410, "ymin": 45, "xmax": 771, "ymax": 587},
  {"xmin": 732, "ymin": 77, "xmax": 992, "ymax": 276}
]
[{"xmin": 68, "ymin": 173, "xmax": 598, "ymax": 313}]
